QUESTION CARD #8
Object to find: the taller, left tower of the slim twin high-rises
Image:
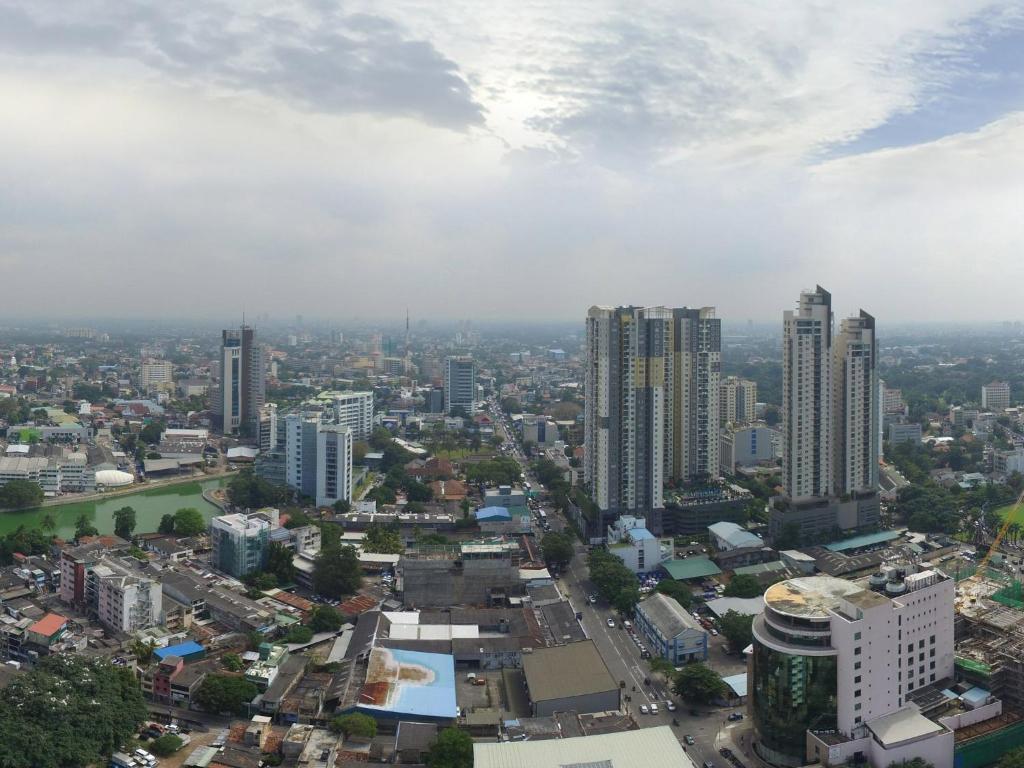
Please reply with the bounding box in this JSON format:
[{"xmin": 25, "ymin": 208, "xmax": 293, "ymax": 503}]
[{"xmin": 782, "ymin": 286, "xmax": 833, "ymax": 502}]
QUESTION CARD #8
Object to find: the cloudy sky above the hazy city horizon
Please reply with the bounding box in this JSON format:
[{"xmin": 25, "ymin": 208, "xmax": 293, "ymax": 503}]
[{"xmin": 0, "ymin": 0, "xmax": 1024, "ymax": 327}]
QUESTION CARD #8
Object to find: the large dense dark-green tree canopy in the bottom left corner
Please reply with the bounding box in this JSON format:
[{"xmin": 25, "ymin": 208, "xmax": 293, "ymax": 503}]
[{"xmin": 0, "ymin": 655, "xmax": 146, "ymax": 768}]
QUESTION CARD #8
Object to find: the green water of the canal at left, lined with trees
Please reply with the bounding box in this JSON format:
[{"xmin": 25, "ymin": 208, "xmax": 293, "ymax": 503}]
[{"xmin": 0, "ymin": 478, "xmax": 224, "ymax": 539}]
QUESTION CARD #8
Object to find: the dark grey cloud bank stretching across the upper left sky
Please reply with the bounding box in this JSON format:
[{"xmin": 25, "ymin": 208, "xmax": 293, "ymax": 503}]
[{"xmin": 0, "ymin": 2, "xmax": 483, "ymax": 129}]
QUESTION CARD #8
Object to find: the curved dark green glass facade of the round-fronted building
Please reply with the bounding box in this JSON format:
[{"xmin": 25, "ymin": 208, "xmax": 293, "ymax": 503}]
[{"xmin": 751, "ymin": 639, "xmax": 837, "ymax": 766}]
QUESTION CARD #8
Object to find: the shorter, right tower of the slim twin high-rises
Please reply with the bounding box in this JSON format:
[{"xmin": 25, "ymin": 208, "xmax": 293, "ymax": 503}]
[{"xmin": 833, "ymin": 310, "xmax": 879, "ymax": 496}]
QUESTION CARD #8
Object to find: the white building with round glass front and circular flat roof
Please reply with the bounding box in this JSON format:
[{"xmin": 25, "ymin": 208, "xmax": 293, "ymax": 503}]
[{"xmin": 750, "ymin": 568, "xmax": 955, "ymax": 768}]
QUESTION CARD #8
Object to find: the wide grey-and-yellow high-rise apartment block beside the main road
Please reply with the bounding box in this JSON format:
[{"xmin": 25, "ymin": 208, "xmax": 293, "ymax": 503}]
[{"xmin": 584, "ymin": 306, "xmax": 721, "ymax": 537}]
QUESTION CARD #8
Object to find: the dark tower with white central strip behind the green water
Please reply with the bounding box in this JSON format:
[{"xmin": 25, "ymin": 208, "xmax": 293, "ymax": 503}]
[{"xmin": 213, "ymin": 326, "xmax": 266, "ymax": 434}]
